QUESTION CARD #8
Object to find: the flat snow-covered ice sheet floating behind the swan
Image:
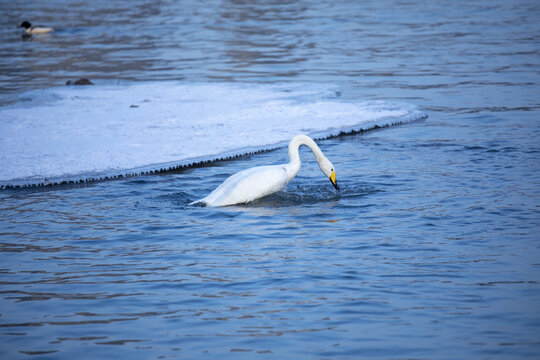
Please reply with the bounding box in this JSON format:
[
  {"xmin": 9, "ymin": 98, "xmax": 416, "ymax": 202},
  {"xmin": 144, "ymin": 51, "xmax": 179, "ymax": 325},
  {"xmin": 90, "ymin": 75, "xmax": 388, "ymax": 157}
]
[{"xmin": 0, "ymin": 82, "xmax": 425, "ymax": 187}]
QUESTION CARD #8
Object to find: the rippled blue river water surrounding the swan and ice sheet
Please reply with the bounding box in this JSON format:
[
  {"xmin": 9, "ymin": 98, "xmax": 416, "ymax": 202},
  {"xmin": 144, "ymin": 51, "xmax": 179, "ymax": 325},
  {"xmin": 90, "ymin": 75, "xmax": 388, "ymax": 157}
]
[{"xmin": 0, "ymin": 1, "xmax": 540, "ymax": 359}]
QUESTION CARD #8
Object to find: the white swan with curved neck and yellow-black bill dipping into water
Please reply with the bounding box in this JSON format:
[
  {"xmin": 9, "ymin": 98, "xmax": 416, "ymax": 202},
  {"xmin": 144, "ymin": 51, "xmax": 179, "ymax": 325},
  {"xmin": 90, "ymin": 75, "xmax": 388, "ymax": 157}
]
[{"xmin": 190, "ymin": 135, "xmax": 339, "ymax": 206}]
